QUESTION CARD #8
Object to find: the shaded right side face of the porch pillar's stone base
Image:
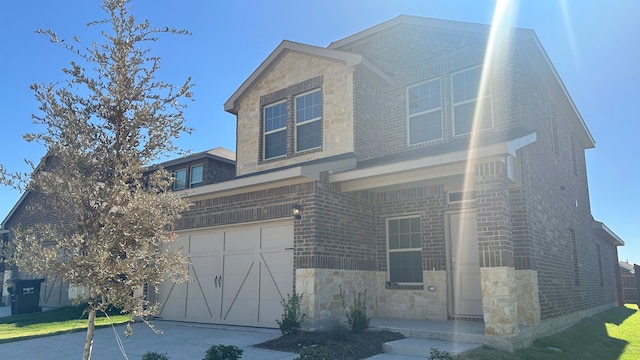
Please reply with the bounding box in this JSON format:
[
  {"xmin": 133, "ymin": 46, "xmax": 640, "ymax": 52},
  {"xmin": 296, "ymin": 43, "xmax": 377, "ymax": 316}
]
[{"xmin": 515, "ymin": 270, "xmax": 540, "ymax": 325}]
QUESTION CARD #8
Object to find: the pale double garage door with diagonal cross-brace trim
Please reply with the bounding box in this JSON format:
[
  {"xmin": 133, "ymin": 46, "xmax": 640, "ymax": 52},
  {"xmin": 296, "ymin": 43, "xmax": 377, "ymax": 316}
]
[{"xmin": 159, "ymin": 222, "xmax": 293, "ymax": 327}]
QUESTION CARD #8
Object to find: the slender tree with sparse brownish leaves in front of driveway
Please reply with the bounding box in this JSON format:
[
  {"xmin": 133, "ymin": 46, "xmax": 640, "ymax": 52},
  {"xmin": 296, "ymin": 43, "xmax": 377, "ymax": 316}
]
[{"xmin": 0, "ymin": 0, "xmax": 192, "ymax": 359}]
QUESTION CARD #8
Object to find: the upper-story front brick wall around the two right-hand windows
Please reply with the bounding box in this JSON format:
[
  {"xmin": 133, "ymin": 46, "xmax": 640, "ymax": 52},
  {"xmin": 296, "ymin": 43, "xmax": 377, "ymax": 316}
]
[{"xmin": 338, "ymin": 25, "xmax": 523, "ymax": 159}]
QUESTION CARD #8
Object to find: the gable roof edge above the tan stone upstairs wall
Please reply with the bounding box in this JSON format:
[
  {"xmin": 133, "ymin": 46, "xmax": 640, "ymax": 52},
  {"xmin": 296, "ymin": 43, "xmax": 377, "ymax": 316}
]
[{"xmin": 224, "ymin": 40, "xmax": 391, "ymax": 114}]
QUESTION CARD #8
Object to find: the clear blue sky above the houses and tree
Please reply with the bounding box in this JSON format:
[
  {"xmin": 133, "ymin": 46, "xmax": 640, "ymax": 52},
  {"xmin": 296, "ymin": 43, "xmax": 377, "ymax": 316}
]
[{"xmin": 0, "ymin": 0, "xmax": 640, "ymax": 263}]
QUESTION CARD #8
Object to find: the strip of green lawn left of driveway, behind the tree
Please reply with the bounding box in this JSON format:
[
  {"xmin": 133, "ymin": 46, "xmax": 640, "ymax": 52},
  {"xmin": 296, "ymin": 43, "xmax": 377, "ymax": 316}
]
[{"xmin": 0, "ymin": 306, "xmax": 129, "ymax": 343}]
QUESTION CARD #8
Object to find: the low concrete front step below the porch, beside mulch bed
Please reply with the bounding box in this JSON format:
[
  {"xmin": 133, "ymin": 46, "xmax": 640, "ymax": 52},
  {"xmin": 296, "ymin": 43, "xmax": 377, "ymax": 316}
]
[{"xmin": 382, "ymin": 338, "xmax": 482, "ymax": 359}]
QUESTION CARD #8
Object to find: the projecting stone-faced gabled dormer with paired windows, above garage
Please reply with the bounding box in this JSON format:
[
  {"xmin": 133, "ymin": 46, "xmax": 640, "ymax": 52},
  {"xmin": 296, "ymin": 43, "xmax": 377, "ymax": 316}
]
[{"xmin": 224, "ymin": 41, "xmax": 390, "ymax": 176}]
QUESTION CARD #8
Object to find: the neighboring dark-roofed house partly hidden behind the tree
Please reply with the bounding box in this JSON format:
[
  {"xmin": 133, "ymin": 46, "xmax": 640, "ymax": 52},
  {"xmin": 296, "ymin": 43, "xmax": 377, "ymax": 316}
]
[{"xmin": 0, "ymin": 147, "xmax": 235, "ymax": 307}]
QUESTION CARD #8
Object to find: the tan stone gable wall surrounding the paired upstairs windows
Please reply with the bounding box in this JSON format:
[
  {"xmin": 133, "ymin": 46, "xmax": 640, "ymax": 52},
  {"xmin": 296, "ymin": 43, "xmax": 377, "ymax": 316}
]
[{"xmin": 236, "ymin": 52, "xmax": 354, "ymax": 176}]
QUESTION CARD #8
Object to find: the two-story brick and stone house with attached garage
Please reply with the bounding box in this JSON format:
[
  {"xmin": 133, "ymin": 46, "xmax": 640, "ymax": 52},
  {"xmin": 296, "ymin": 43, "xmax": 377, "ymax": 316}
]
[{"xmin": 3, "ymin": 16, "xmax": 624, "ymax": 349}]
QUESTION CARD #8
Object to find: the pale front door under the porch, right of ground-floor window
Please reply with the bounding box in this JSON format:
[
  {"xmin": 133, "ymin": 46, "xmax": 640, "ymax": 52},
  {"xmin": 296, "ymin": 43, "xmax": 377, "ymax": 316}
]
[{"xmin": 448, "ymin": 211, "xmax": 483, "ymax": 316}]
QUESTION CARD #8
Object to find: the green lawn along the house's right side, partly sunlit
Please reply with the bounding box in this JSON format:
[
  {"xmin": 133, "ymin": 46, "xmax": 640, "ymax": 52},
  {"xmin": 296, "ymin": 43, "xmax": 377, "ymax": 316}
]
[{"xmin": 455, "ymin": 304, "xmax": 640, "ymax": 360}]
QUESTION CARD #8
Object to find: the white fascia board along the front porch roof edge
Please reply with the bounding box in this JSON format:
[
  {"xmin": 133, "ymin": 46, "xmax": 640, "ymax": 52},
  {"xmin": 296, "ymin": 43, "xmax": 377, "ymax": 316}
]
[{"xmin": 329, "ymin": 132, "xmax": 536, "ymax": 189}]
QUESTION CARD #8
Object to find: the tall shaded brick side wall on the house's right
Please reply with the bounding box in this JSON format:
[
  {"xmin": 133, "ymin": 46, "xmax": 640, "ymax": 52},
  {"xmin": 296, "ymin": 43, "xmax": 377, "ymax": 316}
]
[{"xmin": 510, "ymin": 56, "xmax": 616, "ymax": 319}]
